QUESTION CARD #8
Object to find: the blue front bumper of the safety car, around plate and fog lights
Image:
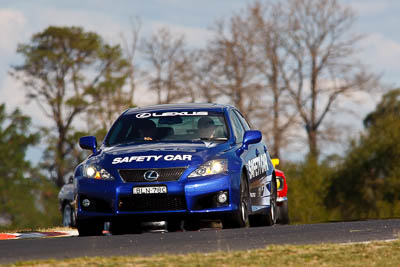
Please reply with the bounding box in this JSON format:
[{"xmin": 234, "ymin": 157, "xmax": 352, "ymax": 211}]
[{"xmin": 77, "ymin": 174, "xmax": 239, "ymax": 221}]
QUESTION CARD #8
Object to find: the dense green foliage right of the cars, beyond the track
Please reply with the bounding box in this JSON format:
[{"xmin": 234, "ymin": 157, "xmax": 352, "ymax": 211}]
[{"xmin": 276, "ymin": 89, "xmax": 400, "ymax": 223}]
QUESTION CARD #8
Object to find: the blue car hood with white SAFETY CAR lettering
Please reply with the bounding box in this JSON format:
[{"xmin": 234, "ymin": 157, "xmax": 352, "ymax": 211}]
[{"xmin": 97, "ymin": 141, "xmax": 230, "ymax": 169}]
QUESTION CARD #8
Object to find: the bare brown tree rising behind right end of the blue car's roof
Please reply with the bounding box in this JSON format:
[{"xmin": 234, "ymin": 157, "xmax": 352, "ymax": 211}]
[{"xmin": 200, "ymin": 2, "xmax": 298, "ymax": 157}]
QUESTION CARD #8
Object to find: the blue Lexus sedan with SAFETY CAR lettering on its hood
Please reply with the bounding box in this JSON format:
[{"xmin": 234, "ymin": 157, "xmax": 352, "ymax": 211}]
[{"xmin": 75, "ymin": 104, "xmax": 277, "ymax": 236}]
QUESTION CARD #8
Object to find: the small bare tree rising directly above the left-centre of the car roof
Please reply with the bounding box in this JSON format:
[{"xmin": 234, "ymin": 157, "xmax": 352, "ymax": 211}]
[{"xmin": 142, "ymin": 28, "xmax": 195, "ymax": 104}]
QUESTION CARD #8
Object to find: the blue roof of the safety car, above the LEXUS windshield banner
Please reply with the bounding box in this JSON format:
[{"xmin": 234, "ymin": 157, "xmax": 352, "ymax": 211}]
[{"xmin": 124, "ymin": 103, "xmax": 234, "ymax": 114}]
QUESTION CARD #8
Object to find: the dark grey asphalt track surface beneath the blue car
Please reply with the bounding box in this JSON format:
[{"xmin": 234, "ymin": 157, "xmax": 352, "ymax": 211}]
[{"xmin": 0, "ymin": 219, "xmax": 400, "ymax": 263}]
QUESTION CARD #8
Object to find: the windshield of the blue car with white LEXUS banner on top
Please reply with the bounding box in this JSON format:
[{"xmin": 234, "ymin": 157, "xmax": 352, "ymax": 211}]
[{"xmin": 104, "ymin": 111, "xmax": 228, "ymax": 146}]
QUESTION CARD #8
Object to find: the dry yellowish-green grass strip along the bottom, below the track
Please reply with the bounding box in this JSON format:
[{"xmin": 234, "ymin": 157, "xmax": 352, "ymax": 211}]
[{"xmin": 6, "ymin": 240, "xmax": 400, "ymax": 267}]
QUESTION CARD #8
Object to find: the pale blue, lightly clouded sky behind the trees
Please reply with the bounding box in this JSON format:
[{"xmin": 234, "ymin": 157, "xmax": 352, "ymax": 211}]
[{"xmin": 0, "ymin": 0, "xmax": 400, "ymax": 161}]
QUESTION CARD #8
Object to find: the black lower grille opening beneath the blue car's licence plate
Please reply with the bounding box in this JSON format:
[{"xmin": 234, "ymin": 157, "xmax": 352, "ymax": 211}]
[{"xmin": 118, "ymin": 195, "xmax": 186, "ymax": 211}]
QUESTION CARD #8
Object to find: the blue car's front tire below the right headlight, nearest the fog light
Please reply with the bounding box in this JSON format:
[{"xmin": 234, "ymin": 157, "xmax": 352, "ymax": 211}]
[{"xmin": 222, "ymin": 174, "xmax": 250, "ymax": 229}]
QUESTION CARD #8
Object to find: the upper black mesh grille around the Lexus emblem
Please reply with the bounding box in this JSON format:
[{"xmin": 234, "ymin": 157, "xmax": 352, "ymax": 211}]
[{"xmin": 118, "ymin": 167, "xmax": 186, "ymax": 183}]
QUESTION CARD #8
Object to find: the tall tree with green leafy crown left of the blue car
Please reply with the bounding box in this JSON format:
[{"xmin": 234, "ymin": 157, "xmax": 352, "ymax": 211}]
[{"xmin": 12, "ymin": 26, "xmax": 129, "ymax": 187}]
